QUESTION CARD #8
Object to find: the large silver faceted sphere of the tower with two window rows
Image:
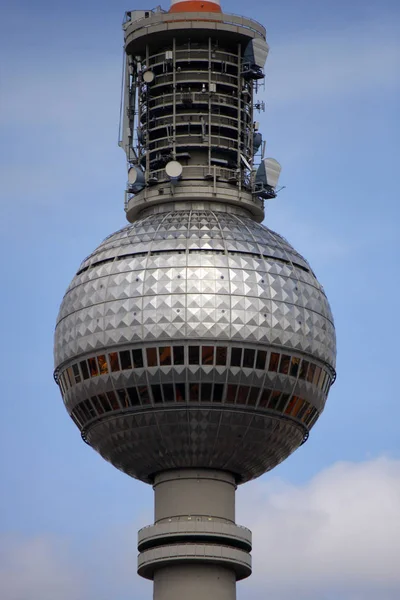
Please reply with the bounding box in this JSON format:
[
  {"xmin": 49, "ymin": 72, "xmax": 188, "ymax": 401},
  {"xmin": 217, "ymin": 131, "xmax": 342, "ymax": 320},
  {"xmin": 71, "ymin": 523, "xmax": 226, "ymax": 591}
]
[{"xmin": 55, "ymin": 203, "xmax": 335, "ymax": 483}]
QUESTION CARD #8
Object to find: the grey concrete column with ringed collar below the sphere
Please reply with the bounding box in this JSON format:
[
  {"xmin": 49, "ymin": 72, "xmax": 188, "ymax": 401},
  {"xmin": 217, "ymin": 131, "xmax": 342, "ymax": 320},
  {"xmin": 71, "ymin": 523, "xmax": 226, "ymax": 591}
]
[{"xmin": 138, "ymin": 469, "xmax": 251, "ymax": 600}]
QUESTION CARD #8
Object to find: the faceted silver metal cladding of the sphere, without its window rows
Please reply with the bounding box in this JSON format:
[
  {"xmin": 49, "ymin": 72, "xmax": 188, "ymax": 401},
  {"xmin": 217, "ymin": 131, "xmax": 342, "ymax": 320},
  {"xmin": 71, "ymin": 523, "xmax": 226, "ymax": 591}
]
[{"xmin": 55, "ymin": 209, "xmax": 336, "ymax": 480}]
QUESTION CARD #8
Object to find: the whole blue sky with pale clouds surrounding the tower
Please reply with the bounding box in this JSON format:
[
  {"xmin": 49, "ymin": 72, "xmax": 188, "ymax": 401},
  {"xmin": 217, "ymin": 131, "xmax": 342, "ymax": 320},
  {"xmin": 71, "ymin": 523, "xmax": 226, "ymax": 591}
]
[{"xmin": 0, "ymin": 0, "xmax": 400, "ymax": 600}]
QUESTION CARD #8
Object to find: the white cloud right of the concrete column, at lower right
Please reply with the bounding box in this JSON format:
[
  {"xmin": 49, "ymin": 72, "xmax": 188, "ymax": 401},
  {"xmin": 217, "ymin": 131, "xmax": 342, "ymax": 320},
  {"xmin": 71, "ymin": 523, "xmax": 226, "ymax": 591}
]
[{"xmin": 237, "ymin": 458, "xmax": 400, "ymax": 600}]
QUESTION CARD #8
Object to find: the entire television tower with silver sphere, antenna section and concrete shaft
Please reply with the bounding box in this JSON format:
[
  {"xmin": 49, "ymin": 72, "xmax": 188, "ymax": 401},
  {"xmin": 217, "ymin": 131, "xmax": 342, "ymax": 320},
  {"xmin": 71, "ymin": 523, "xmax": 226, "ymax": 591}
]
[{"xmin": 55, "ymin": 0, "xmax": 336, "ymax": 600}]
